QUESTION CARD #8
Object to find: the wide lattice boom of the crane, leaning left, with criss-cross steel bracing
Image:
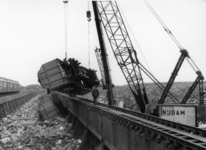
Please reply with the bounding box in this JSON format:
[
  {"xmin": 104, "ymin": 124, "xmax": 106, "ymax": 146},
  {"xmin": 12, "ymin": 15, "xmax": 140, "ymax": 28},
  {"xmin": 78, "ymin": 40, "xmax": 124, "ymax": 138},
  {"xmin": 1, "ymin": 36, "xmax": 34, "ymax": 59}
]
[{"xmin": 92, "ymin": 1, "xmax": 148, "ymax": 112}]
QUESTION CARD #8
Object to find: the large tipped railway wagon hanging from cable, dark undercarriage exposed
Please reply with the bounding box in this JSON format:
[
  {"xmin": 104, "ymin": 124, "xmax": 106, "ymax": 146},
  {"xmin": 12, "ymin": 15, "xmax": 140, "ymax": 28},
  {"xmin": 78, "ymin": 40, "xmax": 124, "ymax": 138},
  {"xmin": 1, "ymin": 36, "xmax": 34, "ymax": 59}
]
[{"xmin": 38, "ymin": 58, "xmax": 100, "ymax": 95}]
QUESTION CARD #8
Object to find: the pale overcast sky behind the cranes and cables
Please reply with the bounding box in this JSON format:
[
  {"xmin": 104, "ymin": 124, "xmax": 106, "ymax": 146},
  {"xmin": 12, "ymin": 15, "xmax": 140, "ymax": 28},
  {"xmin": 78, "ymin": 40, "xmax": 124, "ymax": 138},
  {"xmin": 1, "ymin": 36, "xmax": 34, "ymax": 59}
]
[{"xmin": 0, "ymin": 0, "xmax": 206, "ymax": 86}]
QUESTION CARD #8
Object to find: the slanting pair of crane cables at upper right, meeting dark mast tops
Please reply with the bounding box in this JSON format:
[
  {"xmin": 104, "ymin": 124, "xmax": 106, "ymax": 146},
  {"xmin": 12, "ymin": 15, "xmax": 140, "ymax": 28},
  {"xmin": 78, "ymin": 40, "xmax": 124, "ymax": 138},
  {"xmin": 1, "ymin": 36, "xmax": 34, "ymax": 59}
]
[{"xmin": 144, "ymin": 0, "xmax": 200, "ymax": 73}]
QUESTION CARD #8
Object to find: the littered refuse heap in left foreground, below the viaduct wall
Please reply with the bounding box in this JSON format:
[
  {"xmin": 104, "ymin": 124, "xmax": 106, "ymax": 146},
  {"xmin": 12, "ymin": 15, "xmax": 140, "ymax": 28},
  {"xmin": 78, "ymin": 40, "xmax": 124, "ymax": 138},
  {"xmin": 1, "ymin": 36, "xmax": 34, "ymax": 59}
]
[{"xmin": 0, "ymin": 96, "xmax": 81, "ymax": 150}]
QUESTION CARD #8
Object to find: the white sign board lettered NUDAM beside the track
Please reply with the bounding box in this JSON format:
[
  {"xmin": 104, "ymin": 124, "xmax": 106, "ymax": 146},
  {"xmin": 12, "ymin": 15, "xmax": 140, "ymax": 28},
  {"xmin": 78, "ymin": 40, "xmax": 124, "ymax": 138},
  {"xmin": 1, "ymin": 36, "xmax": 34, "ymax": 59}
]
[{"xmin": 160, "ymin": 106, "xmax": 196, "ymax": 126}]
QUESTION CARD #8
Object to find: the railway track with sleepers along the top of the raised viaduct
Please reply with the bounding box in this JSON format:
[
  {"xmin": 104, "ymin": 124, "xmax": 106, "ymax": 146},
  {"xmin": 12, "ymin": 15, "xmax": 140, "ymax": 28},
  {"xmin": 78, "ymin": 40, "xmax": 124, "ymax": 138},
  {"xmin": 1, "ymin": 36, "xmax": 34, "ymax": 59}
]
[{"xmin": 54, "ymin": 93, "xmax": 206, "ymax": 150}]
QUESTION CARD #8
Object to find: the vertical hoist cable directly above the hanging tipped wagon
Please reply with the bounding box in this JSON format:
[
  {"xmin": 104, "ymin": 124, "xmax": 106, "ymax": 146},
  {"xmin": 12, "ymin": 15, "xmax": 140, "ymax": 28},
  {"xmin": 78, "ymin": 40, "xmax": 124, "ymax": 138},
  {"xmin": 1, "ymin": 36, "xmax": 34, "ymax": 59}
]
[{"xmin": 63, "ymin": 0, "xmax": 68, "ymax": 58}]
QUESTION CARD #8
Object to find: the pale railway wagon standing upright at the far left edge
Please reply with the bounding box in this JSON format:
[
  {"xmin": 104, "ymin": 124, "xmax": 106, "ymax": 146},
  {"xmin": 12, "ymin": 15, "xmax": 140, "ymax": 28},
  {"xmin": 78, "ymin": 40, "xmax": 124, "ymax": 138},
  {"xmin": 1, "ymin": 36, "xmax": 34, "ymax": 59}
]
[{"xmin": 0, "ymin": 77, "xmax": 20, "ymax": 94}]
